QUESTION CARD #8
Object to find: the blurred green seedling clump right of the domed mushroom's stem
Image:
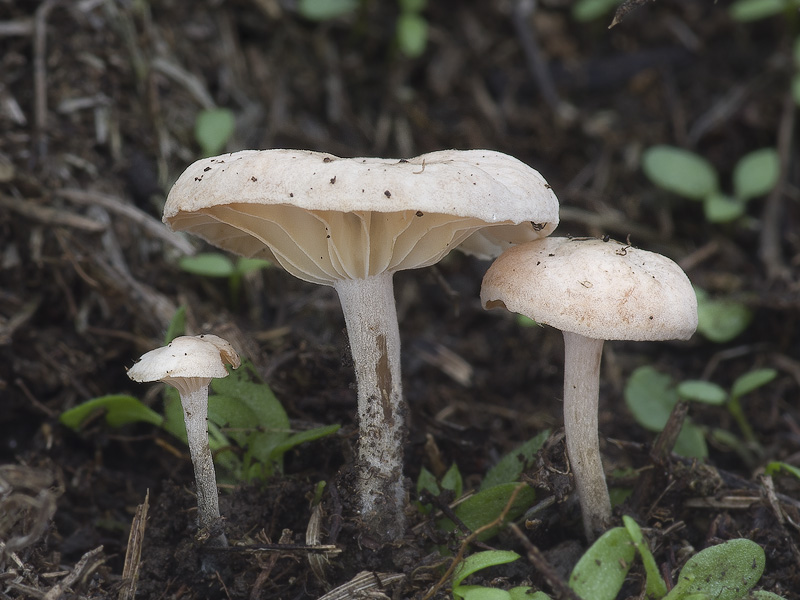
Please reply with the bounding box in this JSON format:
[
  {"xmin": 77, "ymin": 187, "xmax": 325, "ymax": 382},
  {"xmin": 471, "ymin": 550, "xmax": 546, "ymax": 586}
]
[{"xmin": 624, "ymin": 366, "xmax": 777, "ymax": 460}]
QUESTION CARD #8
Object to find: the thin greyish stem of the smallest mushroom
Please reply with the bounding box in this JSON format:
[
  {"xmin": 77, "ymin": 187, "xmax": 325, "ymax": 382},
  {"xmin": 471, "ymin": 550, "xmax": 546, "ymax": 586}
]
[{"xmin": 171, "ymin": 377, "xmax": 228, "ymax": 546}]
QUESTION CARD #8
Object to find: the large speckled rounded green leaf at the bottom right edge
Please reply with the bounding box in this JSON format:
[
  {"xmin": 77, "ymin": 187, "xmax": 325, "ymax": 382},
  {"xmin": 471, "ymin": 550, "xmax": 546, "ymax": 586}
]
[{"xmin": 664, "ymin": 539, "xmax": 765, "ymax": 600}]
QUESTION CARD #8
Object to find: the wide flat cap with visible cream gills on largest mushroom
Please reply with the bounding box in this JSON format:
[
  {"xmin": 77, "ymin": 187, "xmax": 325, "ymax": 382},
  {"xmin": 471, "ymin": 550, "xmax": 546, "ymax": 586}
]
[{"xmin": 163, "ymin": 149, "xmax": 558, "ymax": 285}]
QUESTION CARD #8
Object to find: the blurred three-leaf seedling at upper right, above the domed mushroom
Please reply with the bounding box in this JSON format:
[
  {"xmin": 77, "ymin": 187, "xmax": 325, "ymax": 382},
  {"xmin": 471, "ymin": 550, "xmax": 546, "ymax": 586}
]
[{"xmin": 642, "ymin": 145, "xmax": 780, "ymax": 223}]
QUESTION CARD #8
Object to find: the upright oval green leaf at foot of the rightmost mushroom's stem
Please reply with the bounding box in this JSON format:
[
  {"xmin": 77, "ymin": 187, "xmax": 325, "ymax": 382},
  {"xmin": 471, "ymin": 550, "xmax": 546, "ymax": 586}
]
[{"xmin": 569, "ymin": 527, "xmax": 636, "ymax": 600}]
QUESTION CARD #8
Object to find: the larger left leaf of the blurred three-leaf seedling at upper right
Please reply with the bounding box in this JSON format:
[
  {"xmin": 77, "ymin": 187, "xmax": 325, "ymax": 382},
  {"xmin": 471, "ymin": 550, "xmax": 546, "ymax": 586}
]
[{"xmin": 642, "ymin": 146, "xmax": 719, "ymax": 200}]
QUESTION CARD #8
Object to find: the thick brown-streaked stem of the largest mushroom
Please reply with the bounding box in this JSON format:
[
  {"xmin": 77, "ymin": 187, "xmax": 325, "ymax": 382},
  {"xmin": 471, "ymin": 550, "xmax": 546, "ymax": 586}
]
[{"xmin": 334, "ymin": 272, "xmax": 406, "ymax": 542}]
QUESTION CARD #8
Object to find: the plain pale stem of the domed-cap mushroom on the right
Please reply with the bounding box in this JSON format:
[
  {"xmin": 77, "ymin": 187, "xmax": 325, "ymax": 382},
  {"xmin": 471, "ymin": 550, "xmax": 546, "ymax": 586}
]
[{"xmin": 563, "ymin": 331, "xmax": 611, "ymax": 541}]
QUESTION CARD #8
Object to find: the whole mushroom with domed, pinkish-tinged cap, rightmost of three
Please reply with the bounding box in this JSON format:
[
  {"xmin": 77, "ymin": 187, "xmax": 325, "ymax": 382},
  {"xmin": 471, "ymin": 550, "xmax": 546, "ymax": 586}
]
[{"xmin": 481, "ymin": 237, "xmax": 697, "ymax": 540}]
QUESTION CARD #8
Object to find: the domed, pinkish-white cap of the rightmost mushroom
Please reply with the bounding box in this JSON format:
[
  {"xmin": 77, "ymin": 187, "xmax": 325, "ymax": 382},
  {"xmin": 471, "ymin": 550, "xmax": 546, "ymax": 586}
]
[{"xmin": 481, "ymin": 237, "xmax": 697, "ymax": 340}]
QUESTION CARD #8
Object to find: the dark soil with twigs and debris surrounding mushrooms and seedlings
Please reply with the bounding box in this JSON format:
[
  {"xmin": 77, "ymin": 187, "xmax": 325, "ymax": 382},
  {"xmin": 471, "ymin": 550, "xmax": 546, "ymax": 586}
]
[{"xmin": 0, "ymin": 0, "xmax": 800, "ymax": 600}]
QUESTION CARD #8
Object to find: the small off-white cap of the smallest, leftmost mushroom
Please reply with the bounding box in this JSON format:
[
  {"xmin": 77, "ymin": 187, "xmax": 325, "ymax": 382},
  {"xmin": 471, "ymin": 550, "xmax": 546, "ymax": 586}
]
[{"xmin": 128, "ymin": 334, "xmax": 240, "ymax": 387}]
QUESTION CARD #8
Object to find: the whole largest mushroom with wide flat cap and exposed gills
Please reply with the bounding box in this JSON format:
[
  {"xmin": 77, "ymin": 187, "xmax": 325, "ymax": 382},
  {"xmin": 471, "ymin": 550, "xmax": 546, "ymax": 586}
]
[{"xmin": 164, "ymin": 150, "xmax": 558, "ymax": 542}]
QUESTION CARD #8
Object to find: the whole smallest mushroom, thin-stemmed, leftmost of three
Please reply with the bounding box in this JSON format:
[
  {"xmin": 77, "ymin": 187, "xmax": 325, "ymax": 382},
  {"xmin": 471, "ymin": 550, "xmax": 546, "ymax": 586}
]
[{"xmin": 128, "ymin": 334, "xmax": 241, "ymax": 545}]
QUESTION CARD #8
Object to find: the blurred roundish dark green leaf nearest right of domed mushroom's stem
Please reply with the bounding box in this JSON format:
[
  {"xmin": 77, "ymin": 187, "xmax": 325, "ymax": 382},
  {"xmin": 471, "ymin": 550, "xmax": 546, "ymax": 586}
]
[{"xmin": 624, "ymin": 366, "xmax": 678, "ymax": 431}]
